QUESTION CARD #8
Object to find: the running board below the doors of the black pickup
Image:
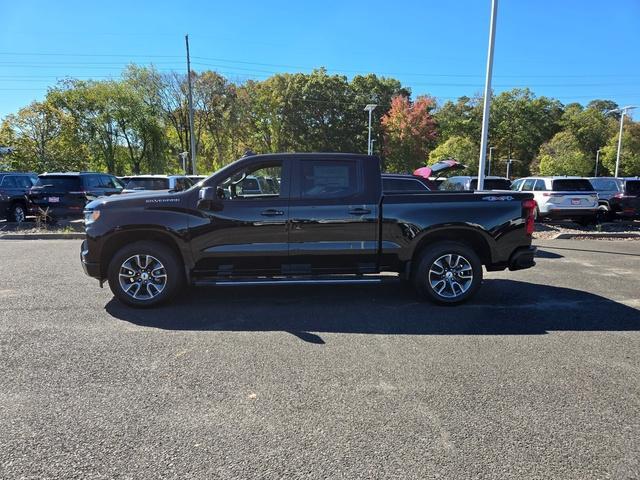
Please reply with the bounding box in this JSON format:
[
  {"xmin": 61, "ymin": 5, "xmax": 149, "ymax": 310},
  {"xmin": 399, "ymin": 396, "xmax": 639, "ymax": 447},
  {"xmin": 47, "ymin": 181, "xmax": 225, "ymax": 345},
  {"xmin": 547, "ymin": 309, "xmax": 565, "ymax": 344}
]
[{"xmin": 193, "ymin": 275, "xmax": 400, "ymax": 287}]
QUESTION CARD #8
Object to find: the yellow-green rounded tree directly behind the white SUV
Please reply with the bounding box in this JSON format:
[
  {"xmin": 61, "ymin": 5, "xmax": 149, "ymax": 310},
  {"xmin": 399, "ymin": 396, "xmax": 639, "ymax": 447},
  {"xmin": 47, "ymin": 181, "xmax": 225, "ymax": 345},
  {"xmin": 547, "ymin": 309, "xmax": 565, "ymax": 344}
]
[{"xmin": 540, "ymin": 132, "xmax": 595, "ymax": 176}]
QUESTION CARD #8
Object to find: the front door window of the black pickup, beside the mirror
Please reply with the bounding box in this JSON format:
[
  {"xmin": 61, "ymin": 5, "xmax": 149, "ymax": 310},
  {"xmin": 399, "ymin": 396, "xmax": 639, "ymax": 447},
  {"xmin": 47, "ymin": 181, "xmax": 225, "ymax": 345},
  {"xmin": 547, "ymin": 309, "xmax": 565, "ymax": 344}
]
[{"xmin": 218, "ymin": 162, "xmax": 282, "ymax": 200}]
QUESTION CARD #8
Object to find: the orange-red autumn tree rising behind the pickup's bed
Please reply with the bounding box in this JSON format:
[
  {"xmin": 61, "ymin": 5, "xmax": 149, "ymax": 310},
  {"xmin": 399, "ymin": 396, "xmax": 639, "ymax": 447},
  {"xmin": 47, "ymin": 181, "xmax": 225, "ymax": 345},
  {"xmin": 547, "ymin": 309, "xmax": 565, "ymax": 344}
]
[{"xmin": 381, "ymin": 96, "xmax": 436, "ymax": 172}]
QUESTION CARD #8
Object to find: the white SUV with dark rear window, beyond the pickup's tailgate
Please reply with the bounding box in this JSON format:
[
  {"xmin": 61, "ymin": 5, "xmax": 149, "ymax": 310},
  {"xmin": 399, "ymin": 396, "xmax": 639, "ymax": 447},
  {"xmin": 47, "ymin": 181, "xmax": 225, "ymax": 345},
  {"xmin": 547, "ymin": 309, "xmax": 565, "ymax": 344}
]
[{"xmin": 511, "ymin": 177, "xmax": 598, "ymax": 224}]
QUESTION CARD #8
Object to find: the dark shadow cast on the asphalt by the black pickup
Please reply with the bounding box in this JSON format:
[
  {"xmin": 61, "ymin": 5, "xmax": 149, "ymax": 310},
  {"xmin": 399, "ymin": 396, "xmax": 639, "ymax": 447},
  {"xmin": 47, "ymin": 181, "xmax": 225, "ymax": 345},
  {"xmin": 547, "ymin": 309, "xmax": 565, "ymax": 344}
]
[{"xmin": 105, "ymin": 280, "xmax": 640, "ymax": 344}]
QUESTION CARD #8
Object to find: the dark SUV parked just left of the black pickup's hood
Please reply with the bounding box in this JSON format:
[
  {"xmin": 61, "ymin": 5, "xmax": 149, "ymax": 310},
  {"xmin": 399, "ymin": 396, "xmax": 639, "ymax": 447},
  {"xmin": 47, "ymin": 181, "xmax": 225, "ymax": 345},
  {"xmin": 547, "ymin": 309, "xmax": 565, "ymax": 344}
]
[{"xmin": 27, "ymin": 172, "xmax": 123, "ymax": 218}]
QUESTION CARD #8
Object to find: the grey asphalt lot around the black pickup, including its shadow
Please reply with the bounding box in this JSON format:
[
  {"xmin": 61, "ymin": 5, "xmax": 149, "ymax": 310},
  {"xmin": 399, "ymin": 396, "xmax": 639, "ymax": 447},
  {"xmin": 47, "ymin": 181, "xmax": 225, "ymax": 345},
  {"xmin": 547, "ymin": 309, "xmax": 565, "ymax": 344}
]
[{"xmin": 0, "ymin": 240, "xmax": 640, "ymax": 479}]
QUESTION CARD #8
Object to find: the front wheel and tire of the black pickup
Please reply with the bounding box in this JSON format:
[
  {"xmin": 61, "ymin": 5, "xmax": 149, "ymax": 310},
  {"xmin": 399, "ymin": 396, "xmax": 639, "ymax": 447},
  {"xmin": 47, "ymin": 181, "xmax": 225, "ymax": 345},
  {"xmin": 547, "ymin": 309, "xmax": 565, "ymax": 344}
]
[{"xmin": 107, "ymin": 241, "xmax": 185, "ymax": 308}]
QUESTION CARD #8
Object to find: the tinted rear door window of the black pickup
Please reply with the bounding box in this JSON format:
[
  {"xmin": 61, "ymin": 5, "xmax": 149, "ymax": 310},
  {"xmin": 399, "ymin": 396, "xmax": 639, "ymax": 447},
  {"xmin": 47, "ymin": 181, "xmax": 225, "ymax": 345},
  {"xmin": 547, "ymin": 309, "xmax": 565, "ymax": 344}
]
[{"xmin": 300, "ymin": 160, "xmax": 358, "ymax": 198}]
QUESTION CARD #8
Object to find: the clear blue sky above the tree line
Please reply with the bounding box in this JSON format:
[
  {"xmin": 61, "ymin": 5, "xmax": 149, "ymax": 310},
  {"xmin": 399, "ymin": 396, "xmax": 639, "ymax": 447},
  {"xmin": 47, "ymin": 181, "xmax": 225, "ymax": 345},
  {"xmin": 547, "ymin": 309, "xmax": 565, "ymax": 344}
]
[{"xmin": 0, "ymin": 0, "xmax": 640, "ymax": 117}]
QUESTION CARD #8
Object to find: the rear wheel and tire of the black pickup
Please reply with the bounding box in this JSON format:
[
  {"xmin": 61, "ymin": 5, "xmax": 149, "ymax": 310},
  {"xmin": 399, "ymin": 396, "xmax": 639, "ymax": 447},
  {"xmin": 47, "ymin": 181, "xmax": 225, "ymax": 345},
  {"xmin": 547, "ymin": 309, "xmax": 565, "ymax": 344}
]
[{"xmin": 413, "ymin": 242, "xmax": 482, "ymax": 305}]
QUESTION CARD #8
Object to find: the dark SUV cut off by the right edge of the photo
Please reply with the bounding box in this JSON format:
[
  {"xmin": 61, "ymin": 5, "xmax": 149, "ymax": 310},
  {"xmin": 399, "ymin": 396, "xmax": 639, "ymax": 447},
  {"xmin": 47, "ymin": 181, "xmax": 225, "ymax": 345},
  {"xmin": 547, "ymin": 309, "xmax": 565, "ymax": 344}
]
[{"xmin": 589, "ymin": 177, "xmax": 640, "ymax": 219}]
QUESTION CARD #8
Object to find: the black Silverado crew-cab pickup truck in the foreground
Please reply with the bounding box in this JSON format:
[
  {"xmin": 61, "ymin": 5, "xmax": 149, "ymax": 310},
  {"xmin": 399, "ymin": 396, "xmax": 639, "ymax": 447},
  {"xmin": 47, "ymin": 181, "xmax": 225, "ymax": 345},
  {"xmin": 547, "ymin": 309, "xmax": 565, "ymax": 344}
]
[{"xmin": 81, "ymin": 153, "xmax": 535, "ymax": 307}]
